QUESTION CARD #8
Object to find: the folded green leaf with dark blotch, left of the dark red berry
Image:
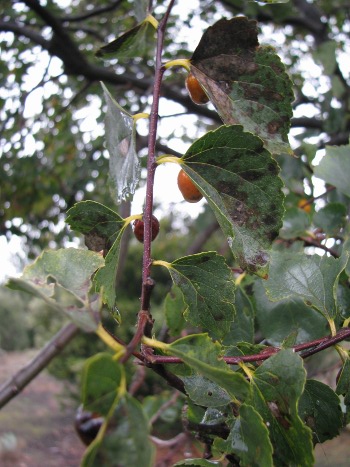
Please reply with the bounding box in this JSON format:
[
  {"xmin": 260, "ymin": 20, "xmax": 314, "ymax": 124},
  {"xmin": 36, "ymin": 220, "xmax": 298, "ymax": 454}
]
[{"xmin": 66, "ymin": 201, "xmax": 128, "ymax": 311}]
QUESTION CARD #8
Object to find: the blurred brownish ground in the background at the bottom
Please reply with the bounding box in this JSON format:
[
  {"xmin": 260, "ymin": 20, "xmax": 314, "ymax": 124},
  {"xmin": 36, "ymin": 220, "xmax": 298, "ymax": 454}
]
[{"xmin": 0, "ymin": 351, "xmax": 350, "ymax": 467}]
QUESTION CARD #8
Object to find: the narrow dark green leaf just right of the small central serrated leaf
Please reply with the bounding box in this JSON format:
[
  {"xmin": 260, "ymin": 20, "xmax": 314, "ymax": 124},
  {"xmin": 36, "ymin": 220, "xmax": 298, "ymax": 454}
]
[{"xmin": 223, "ymin": 287, "xmax": 255, "ymax": 345}]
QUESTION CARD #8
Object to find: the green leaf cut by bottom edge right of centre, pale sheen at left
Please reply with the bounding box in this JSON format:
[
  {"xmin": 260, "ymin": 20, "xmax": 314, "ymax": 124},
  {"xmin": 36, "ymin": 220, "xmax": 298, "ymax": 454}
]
[{"xmin": 214, "ymin": 404, "xmax": 273, "ymax": 467}]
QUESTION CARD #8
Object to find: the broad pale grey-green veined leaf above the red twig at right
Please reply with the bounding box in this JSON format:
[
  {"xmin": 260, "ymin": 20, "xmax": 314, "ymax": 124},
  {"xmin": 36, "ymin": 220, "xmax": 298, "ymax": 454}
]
[{"xmin": 264, "ymin": 251, "xmax": 348, "ymax": 321}]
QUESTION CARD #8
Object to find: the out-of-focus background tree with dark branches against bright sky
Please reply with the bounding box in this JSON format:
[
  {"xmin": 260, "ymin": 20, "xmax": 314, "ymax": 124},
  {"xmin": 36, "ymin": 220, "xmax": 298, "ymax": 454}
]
[{"xmin": 0, "ymin": 0, "xmax": 349, "ymax": 260}]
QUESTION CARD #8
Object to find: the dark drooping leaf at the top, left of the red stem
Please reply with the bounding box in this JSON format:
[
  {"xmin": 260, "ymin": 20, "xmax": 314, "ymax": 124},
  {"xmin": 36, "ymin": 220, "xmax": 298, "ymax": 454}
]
[{"xmin": 96, "ymin": 18, "xmax": 155, "ymax": 59}]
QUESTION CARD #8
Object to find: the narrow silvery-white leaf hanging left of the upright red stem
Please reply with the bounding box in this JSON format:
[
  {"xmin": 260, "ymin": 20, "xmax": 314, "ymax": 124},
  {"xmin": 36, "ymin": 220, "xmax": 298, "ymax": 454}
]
[{"xmin": 101, "ymin": 83, "xmax": 141, "ymax": 204}]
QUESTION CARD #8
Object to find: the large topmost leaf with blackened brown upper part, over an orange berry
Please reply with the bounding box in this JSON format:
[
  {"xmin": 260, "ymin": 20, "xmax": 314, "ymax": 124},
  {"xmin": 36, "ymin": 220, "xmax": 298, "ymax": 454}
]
[{"xmin": 191, "ymin": 17, "xmax": 294, "ymax": 154}]
